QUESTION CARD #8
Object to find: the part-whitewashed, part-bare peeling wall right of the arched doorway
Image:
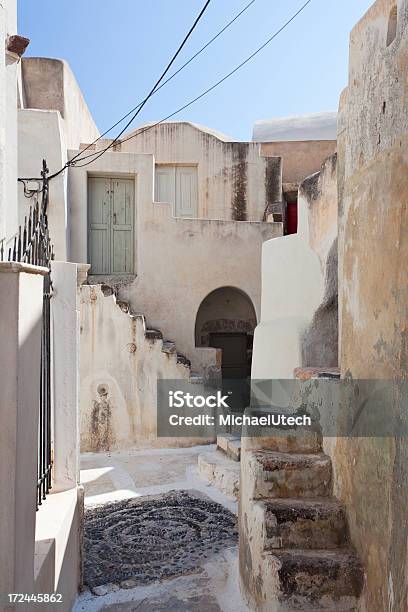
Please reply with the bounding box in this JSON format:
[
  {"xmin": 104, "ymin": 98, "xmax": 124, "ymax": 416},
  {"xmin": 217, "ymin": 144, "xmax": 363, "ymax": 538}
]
[{"xmin": 251, "ymin": 155, "xmax": 337, "ymax": 412}]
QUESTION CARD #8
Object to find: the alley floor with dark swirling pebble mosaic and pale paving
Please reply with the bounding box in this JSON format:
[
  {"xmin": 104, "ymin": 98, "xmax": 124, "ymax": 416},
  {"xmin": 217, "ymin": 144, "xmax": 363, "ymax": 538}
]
[{"xmin": 74, "ymin": 446, "xmax": 247, "ymax": 612}]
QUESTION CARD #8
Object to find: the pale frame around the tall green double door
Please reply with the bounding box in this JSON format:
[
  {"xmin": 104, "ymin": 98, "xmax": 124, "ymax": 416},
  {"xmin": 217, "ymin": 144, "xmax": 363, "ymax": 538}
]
[{"xmin": 85, "ymin": 172, "xmax": 138, "ymax": 280}]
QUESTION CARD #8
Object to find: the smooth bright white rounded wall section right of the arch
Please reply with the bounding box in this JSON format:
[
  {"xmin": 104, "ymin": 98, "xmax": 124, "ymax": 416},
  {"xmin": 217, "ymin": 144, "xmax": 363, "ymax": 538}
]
[{"xmin": 252, "ymin": 197, "xmax": 324, "ymax": 379}]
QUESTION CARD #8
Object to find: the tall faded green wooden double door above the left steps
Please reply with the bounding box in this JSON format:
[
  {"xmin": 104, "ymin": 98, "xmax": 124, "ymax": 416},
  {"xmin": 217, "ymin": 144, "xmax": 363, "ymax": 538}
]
[{"xmin": 88, "ymin": 177, "xmax": 134, "ymax": 274}]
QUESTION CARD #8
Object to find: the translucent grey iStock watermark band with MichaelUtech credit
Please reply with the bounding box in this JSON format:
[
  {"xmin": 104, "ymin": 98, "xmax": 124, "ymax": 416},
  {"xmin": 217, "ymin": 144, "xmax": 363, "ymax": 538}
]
[{"xmin": 157, "ymin": 378, "xmax": 408, "ymax": 441}]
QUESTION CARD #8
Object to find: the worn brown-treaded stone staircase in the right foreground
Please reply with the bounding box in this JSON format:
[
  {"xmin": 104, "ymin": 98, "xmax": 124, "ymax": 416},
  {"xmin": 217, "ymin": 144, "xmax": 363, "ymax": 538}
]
[{"xmin": 240, "ymin": 426, "xmax": 364, "ymax": 612}]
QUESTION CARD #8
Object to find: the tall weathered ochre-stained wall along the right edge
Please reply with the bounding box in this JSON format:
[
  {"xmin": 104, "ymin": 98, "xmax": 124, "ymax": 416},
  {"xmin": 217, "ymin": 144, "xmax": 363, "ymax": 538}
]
[{"xmin": 327, "ymin": 0, "xmax": 408, "ymax": 612}]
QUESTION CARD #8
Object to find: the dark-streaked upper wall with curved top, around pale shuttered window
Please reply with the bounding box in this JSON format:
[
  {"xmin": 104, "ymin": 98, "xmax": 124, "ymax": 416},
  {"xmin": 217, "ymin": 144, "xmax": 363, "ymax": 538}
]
[{"xmin": 99, "ymin": 122, "xmax": 281, "ymax": 221}]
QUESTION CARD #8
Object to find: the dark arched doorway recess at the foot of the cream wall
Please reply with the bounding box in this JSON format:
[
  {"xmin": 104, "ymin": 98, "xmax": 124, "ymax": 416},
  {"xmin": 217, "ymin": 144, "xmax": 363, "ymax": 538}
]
[{"xmin": 195, "ymin": 287, "xmax": 256, "ymax": 379}]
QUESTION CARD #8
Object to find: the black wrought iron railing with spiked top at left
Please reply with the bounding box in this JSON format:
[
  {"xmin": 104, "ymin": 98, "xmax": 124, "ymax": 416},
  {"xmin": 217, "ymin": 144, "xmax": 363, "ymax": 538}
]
[{"xmin": 0, "ymin": 160, "xmax": 54, "ymax": 508}]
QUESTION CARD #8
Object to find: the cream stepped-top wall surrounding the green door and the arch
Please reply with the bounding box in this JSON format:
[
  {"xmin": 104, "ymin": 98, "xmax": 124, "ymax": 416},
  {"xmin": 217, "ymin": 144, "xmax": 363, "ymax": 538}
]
[{"xmin": 69, "ymin": 152, "xmax": 282, "ymax": 370}]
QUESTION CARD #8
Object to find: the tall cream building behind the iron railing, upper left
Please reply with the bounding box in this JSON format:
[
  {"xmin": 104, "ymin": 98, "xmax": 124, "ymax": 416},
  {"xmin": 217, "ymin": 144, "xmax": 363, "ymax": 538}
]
[{"xmin": 18, "ymin": 57, "xmax": 99, "ymax": 261}]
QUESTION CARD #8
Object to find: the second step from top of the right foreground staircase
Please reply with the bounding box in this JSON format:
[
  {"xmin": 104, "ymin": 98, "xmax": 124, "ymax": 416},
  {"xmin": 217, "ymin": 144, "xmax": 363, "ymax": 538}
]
[{"xmin": 246, "ymin": 450, "xmax": 332, "ymax": 499}]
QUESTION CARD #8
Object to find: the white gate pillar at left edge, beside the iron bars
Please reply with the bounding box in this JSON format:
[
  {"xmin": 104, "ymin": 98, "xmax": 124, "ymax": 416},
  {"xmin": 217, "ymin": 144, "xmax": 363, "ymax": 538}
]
[{"xmin": 0, "ymin": 262, "xmax": 45, "ymax": 594}]
